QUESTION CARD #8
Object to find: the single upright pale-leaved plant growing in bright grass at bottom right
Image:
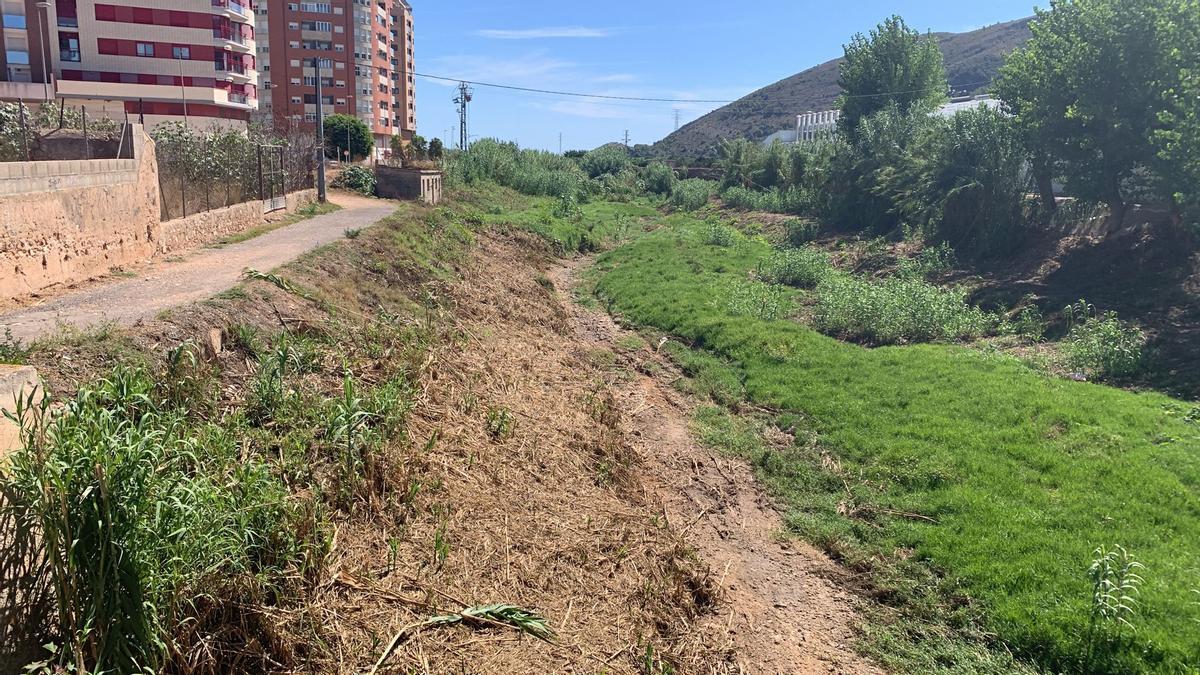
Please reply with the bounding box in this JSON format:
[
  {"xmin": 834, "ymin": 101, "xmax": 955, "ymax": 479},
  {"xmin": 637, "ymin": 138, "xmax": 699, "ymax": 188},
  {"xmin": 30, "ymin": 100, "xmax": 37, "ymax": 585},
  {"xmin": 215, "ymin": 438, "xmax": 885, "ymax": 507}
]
[{"xmin": 1084, "ymin": 545, "xmax": 1145, "ymax": 673}]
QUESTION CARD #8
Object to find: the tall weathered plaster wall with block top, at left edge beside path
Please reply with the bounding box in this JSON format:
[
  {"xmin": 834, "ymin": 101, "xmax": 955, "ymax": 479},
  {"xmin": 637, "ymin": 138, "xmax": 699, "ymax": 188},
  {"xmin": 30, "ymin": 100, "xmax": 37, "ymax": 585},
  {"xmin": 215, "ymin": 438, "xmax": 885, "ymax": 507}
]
[{"xmin": 0, "ymin": 127, "xmax": 160, "ymax": 298}]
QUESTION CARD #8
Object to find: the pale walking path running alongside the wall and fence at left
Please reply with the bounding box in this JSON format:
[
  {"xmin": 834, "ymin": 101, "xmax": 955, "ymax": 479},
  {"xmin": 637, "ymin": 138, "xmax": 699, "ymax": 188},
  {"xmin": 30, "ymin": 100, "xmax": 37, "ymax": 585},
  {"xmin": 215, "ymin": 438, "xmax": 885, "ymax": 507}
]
[{"xmin": 0, "ymin": 193, "xmax": 395, "ymax": 341}]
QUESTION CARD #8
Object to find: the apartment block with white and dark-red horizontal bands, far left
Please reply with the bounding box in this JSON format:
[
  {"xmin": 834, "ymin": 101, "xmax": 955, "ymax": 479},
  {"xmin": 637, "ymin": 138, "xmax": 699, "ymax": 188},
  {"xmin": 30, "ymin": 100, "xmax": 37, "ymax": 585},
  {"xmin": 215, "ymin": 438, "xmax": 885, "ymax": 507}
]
[{"xmin": 0, "ymin": 0, "xmax": 258, "ymax": 129}]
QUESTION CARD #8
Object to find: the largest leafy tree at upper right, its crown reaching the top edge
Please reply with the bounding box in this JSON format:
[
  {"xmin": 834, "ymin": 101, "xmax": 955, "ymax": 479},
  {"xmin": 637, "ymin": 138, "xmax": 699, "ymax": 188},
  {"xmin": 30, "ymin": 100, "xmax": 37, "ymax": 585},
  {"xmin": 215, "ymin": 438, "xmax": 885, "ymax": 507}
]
[{"xmin": 996, "ymin": 0, "xmax": 1180, "ymax": 219}]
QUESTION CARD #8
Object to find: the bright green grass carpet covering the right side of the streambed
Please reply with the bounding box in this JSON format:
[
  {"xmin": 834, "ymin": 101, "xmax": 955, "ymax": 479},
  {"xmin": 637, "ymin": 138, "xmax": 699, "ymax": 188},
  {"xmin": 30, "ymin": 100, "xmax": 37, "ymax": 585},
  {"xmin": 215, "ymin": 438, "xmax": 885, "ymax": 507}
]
[{"xmin": 596, "ymin": 216, "xmax": 1200, "ymax": 673}]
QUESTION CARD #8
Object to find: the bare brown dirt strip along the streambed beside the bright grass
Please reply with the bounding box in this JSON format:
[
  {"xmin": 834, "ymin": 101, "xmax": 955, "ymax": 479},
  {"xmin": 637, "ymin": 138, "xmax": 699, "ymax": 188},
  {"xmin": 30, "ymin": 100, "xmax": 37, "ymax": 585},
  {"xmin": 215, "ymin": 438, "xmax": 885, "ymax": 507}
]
[{"xmin": 548, "ymin": 258, "xmax": 882, "ymax": 674}]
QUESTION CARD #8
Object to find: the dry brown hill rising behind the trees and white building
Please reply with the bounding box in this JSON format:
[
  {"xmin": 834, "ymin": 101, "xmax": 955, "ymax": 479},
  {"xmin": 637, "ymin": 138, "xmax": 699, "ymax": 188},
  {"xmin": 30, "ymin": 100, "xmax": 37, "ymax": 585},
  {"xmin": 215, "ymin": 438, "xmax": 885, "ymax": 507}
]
[{"xmin": 654, "ymin": 18, "xmax": 1030, "ymax": 160}]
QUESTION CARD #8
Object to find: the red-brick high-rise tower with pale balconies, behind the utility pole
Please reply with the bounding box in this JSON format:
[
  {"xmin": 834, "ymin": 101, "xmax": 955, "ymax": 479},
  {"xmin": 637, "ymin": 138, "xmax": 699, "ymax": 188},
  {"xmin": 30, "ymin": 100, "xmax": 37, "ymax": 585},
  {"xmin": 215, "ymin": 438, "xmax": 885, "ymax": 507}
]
[{"xmin": 256, "ymin": 0, "xmax": 416, "ymax": 157}]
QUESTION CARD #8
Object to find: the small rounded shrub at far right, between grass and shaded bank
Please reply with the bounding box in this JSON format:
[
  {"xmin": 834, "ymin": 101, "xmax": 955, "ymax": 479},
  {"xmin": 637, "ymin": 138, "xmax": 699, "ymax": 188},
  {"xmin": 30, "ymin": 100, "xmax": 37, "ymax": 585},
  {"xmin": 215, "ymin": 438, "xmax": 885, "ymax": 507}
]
[{"xmin": 1062, "ymin": 300, "xmax": 1146, "ymax": 377}]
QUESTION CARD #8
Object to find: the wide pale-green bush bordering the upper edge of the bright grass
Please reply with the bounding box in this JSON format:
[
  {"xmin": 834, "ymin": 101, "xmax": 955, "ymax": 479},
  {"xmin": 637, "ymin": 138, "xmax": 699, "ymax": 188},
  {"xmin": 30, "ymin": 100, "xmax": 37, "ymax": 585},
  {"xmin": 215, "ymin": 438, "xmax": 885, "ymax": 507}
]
[{"xmin": 815, "ymin": 273, "xmax": 997, "ymax": 345}]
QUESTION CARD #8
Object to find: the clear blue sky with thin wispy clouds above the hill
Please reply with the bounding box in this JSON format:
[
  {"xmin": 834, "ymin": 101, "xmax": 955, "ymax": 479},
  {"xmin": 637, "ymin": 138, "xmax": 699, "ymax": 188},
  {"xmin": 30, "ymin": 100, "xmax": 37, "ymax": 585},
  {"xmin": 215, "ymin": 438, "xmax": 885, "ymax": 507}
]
[{"xmin": 410, "ymin": 0, "xmax": 1045, "ymax": 151}]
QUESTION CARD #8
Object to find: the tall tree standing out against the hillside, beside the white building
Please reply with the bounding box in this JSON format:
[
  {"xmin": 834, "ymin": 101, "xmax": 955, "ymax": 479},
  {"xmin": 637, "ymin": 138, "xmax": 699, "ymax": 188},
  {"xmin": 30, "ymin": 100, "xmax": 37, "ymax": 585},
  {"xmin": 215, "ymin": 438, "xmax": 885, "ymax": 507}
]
[{"xmin": 838, "ymin": 16, "xmax": 948, "ymax": 137}]
